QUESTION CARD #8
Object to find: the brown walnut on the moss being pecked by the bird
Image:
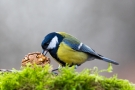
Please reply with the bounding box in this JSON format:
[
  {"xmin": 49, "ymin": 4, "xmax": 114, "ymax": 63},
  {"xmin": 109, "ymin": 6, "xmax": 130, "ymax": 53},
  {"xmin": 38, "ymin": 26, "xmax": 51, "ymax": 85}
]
[{"xmin": 22, "ymin": 52, "xmax": 50, "ymax": 66}]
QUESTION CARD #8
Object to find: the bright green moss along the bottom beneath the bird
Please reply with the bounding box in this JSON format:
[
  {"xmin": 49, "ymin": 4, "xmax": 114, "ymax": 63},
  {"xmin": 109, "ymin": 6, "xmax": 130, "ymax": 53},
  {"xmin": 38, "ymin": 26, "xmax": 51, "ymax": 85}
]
[{"xmin": 0, "ymin": 65, "xmax": 135, "ymax": 90}]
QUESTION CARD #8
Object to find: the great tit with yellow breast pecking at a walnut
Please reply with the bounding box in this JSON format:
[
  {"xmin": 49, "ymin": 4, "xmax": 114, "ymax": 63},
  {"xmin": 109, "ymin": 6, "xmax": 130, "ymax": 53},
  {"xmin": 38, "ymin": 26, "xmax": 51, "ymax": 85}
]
[{"xmin": 41, "ymin": 32, "xmax": 119, "ymax": 66}]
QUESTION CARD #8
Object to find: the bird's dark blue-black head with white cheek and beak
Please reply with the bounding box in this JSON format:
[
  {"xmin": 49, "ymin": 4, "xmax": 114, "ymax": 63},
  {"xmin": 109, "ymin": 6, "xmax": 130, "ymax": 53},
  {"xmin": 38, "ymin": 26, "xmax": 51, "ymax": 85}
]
[{"xmin": 41, "ymin": 32, "xmax": 63, "ymax": 55}]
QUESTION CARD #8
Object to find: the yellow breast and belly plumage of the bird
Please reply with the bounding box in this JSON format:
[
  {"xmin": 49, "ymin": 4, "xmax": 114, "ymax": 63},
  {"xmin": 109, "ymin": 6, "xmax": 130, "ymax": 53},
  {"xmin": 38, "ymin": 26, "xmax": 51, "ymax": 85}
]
[{"xmin": 57, "ymin": 42, "xmax": 88, "ymax": 65}]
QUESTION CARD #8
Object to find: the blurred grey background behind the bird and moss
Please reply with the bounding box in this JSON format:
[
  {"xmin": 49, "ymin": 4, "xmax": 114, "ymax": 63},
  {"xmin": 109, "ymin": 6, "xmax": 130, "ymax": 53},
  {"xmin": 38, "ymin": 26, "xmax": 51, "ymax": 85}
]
[{"xmin": 0, "ymin": 0, "xmax": 135, "ymax": 83}]
